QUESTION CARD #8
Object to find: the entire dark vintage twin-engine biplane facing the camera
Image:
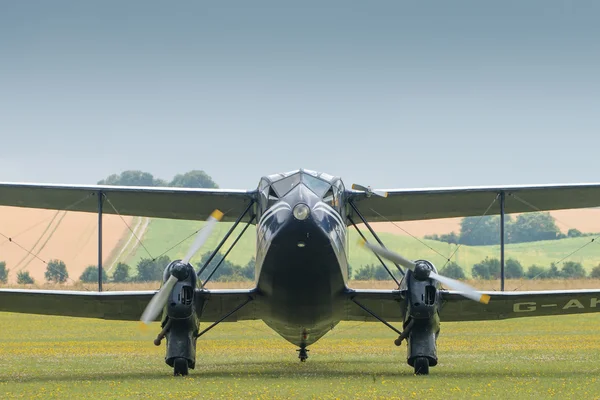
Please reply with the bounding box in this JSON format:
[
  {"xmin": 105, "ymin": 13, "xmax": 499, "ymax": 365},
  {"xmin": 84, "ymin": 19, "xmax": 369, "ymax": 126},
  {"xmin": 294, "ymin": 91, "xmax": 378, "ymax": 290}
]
[{"xmin": 0, "ymin": 169, "xmax": 600, "ymax": 375}]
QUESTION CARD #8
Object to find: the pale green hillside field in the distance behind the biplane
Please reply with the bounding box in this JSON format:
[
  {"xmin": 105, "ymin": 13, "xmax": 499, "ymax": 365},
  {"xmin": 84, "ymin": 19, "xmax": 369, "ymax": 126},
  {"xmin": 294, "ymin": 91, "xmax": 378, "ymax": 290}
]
[{"xmin": 126, "ymin": 219, "xmax": 600, "ymax": 277}]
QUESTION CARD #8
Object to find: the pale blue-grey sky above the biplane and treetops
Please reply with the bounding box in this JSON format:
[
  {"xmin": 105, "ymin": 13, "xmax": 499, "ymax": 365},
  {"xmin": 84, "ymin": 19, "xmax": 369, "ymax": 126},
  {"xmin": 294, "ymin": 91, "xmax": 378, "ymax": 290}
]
[{"xmin": 0, "ymin": 0, "xmax": 600, "ymax": 188}]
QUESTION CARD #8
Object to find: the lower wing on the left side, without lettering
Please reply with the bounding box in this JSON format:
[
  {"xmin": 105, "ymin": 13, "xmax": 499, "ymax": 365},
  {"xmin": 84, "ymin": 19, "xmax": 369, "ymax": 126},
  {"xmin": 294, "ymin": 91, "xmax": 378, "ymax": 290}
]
[{"xmin": 0, "ymin": 289, "xmax": 258, "ymax": 322}]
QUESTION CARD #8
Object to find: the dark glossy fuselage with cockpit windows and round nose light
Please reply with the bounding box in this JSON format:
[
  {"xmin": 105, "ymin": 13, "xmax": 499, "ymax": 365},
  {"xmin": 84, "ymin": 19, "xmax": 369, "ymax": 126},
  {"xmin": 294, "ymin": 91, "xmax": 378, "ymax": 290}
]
[{"xmin": 256, "ymin": 170, "xmax": 348, "ymax": 347}]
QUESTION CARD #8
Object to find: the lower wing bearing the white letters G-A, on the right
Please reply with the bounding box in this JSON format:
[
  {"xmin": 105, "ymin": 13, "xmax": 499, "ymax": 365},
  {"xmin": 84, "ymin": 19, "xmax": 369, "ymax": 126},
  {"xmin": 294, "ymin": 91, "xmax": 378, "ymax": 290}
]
[{"xmin": 345, "ymin": 289, "xmax": 600, "ymax": 322}]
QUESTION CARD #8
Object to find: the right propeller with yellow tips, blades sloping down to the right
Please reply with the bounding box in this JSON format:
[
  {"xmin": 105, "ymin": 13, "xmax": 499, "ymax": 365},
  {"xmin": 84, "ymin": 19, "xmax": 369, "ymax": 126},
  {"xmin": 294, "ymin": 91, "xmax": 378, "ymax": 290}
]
[{"xmin": 360, "ymin": 240, "xmax": 490, "ymax": 304}]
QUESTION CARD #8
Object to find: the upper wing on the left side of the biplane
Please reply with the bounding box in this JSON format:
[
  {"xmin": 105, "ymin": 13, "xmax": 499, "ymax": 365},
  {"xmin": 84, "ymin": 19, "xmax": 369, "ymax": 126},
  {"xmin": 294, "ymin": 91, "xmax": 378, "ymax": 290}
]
[{"xmin": 0, "ymin": 183, "xmax": 256, "ymax": 221}]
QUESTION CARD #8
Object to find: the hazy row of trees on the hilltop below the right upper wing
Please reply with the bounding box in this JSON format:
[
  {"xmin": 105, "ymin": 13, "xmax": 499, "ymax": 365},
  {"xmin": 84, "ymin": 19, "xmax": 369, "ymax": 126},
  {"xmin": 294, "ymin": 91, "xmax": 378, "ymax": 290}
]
[{"xmin": 424, "ymin": 212, "xmax": 596, "ymax": 246}]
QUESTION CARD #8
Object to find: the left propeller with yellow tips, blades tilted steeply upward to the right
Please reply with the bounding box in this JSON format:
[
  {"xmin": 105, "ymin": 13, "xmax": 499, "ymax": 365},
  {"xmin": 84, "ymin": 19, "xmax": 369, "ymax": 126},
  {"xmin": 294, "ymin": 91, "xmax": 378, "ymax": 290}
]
[{"xmin": 140, "ymin": 210, "xmax": 223, "ymax": 325}]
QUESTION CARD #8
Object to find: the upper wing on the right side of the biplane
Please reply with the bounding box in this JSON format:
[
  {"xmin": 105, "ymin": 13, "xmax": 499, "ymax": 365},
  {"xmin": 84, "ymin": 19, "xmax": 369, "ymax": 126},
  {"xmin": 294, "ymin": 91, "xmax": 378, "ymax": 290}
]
[{"xmin": 348, "ymin": 183, "xmax": 600, "ymax": 221}]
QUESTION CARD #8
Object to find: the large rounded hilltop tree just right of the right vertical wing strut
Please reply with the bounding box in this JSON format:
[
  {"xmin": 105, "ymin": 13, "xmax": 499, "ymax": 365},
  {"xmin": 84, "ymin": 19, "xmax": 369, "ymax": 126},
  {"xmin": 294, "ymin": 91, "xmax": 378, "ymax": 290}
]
[{"xmin": 507, "ymin": 212, "xmax": 560, "ymax": 243}]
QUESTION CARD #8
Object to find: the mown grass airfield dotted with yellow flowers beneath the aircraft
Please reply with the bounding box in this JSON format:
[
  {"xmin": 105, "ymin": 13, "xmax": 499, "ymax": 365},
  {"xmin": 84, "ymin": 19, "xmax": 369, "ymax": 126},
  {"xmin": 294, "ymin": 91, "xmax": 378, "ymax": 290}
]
[{"xmin": 0, "ymin": 313, "xmax": 600, "ymax": 399}]
